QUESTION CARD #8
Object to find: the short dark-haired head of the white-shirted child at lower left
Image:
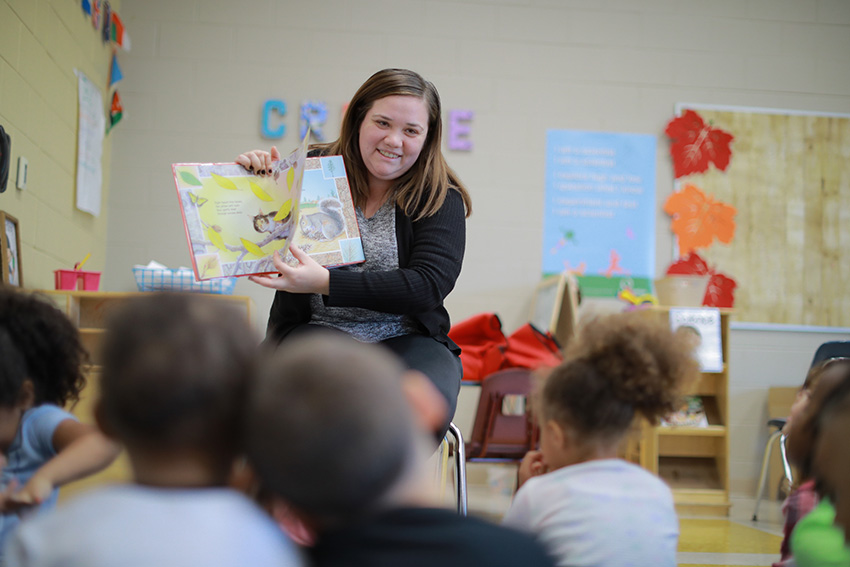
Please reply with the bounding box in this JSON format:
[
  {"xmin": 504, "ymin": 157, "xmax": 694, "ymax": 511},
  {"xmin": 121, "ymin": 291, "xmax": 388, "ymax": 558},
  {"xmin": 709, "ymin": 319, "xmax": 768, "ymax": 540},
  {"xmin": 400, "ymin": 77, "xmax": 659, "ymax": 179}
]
[{"xmin": 97, "ymin": 294, "xmax": 257, "ymax": 474}]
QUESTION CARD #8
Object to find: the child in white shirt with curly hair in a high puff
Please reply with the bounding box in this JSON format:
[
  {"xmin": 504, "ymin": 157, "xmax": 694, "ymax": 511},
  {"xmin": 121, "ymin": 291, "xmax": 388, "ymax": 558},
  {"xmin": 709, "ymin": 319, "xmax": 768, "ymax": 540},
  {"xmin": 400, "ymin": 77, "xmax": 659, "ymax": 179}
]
[{"xmin": 504, "ymin": 312, "xmax": 699, "ymax": 567}]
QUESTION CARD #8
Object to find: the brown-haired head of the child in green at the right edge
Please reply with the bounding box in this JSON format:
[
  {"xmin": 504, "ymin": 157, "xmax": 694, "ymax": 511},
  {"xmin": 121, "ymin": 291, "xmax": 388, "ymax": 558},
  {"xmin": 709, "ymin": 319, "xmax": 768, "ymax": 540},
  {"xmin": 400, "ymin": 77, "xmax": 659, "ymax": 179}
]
[{"xmin": 813, "ymin": 372, "xmax": 850, "ymax": 543}]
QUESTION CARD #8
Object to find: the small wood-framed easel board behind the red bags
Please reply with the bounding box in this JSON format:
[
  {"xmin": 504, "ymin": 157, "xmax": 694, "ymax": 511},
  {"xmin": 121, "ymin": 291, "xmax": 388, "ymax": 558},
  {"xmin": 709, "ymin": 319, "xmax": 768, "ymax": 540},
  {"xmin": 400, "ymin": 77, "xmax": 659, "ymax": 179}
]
[{"xmin": 529, "ymin": 273, "xmax": 578, "ymax": 347}]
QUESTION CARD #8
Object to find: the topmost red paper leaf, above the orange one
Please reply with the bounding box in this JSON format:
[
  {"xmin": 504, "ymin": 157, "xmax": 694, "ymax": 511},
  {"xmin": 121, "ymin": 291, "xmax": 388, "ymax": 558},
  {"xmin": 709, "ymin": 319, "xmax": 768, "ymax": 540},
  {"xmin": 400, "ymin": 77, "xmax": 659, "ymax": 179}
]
[{"xmin": 664, "ymin": 110, "xmax": 735, "ymax": 179}]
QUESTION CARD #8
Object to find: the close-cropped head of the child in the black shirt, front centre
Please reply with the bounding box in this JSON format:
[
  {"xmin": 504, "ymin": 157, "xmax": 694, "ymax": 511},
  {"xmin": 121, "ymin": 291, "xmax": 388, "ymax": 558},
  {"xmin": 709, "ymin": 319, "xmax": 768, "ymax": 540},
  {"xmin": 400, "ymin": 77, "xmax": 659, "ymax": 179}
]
[{"xmin": 246, "ymin": 333, "xmax": 428, "ymax": 529}]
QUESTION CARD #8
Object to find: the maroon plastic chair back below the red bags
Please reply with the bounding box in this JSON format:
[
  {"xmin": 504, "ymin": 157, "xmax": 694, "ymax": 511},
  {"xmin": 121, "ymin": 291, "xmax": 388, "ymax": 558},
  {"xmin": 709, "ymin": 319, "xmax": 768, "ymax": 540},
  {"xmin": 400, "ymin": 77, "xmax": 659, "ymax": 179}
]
[{"xmin": 466, "ymin": 368, "xmax": 537, "ymax": 460}]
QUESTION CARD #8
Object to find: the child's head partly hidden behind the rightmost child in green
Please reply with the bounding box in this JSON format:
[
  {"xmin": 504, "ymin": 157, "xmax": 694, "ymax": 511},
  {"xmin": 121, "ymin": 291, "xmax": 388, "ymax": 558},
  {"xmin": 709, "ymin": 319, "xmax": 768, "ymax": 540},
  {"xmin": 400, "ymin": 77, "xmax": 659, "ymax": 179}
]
[{"xmin": 785, "ymin": 358, "xmax": 850, "ymax": 479}]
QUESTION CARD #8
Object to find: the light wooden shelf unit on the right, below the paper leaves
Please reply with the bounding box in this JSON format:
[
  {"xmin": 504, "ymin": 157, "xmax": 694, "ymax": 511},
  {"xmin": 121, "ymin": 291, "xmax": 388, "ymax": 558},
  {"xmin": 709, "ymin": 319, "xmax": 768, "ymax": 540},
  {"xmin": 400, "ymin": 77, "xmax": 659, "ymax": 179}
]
[{"xmin": 639, "ymin": 307, "xmax": 732, "ymax": 516}]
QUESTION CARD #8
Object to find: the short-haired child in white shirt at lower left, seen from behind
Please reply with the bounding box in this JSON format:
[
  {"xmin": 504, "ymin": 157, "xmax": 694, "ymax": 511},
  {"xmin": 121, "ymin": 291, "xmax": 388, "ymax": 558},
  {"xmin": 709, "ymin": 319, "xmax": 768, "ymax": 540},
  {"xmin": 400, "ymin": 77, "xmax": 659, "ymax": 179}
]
[{"xmin": 7, "ymin": 294, "xmax": 300, "ymax": 567}]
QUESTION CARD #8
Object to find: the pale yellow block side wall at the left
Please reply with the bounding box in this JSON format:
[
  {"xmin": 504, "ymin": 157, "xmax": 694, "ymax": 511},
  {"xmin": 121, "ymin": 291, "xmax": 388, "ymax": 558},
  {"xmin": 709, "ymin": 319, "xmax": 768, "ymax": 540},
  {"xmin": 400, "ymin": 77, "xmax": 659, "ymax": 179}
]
[{"xmin": 0, "ymin": 0, "xmax": 121, "ymax": 289}]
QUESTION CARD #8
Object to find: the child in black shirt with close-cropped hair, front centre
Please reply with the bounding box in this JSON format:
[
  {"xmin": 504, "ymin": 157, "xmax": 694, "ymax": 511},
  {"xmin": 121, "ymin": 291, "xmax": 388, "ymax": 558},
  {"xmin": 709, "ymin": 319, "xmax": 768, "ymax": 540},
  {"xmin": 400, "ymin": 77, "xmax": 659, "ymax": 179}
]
[{"xmin": 247, "ymin": 333, "xmax": 552, "ymax": 567}]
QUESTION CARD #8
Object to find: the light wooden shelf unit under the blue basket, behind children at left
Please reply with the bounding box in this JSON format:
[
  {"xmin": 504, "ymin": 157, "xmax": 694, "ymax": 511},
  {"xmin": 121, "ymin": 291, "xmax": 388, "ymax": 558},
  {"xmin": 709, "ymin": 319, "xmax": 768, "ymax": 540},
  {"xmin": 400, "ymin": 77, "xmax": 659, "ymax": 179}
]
[{"xmin": 39, "ymin": 290, "xmax": 254, "ymax": 499}]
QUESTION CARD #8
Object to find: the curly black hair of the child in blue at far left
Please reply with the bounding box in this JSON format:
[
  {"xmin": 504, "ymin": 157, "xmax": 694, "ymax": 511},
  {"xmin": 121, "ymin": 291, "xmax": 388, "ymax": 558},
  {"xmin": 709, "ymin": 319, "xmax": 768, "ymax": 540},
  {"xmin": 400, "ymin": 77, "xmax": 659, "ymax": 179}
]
[{"xmin": 0, "ymin": 285, "xmax": 88, "ymax": 407}]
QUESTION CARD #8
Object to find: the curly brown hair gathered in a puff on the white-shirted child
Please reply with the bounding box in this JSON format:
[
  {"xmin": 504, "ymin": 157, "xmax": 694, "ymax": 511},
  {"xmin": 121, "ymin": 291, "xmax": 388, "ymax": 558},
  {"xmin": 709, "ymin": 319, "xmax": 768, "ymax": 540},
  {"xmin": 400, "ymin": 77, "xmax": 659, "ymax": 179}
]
[{"xmin": 540, "ymin": 311, "xmax": 699, "ymax": 439}]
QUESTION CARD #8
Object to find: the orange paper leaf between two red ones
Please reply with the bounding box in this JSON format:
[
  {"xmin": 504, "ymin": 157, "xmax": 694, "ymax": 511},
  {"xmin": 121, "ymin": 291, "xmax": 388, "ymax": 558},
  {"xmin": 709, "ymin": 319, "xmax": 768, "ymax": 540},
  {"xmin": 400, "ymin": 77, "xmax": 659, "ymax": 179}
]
[{"xmin": 664, "ymin": 185, "xmax": 738, "ymax": 256}]
